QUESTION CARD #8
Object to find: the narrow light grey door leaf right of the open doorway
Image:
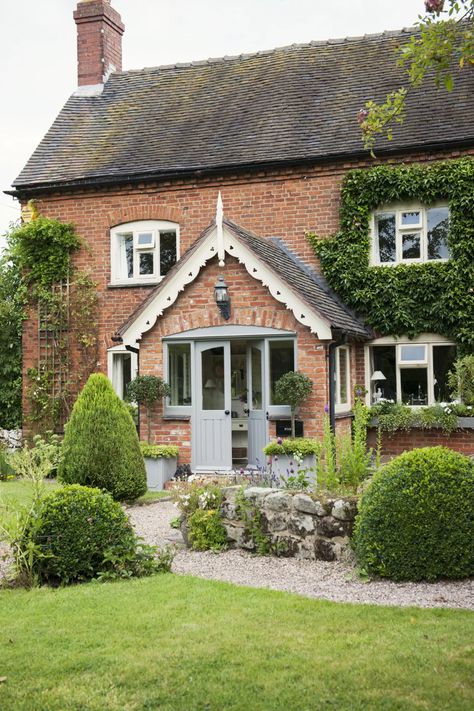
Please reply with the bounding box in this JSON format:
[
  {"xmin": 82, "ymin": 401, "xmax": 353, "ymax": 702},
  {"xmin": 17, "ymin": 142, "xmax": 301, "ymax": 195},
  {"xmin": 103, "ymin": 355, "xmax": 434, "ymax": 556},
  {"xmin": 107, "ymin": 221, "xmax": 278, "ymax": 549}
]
[{"xmin": 247, "ymin": 341, "xmax": 268, "ymax": 467}]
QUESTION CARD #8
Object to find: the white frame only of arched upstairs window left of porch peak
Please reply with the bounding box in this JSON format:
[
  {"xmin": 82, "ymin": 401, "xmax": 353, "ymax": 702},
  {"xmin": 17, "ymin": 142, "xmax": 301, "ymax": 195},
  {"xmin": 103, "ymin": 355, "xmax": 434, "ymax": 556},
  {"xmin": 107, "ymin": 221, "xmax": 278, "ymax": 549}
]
[{"xmin": 110, "ymin": 220, "xmax": 180, "ymax": 286}]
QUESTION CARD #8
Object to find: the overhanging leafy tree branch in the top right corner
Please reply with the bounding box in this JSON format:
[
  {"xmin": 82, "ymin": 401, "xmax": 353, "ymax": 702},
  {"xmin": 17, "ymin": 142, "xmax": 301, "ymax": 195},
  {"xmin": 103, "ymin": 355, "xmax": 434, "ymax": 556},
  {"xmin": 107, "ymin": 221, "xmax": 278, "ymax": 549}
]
[{"xmin": 359, "ymin": 0, "xmax": 474, "ymax": 154}]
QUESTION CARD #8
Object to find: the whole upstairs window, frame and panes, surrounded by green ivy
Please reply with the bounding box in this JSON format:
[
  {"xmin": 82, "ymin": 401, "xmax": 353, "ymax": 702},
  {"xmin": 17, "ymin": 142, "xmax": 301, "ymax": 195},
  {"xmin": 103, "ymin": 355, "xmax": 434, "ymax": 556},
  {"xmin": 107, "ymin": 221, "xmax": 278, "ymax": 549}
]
[{"xmin": 372, "ymin": 205, "xmax": 450, "ymax": 265}]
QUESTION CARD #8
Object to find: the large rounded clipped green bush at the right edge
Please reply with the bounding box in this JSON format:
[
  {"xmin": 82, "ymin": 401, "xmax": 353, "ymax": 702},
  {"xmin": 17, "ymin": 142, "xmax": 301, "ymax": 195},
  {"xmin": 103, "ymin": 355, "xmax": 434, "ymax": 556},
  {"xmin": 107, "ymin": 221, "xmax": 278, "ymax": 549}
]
[{"xmin": 354, "ymin": 447, "xmax": 474, "ymax": 581}]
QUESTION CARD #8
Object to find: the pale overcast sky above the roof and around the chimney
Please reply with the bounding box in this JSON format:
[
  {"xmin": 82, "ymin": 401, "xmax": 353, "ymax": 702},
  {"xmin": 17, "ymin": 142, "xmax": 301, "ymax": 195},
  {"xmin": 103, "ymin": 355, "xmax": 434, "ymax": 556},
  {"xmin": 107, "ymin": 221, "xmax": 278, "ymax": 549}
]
[{"xmin": 0, "ymin": 0, "xmax": 424, "ymax": 249}]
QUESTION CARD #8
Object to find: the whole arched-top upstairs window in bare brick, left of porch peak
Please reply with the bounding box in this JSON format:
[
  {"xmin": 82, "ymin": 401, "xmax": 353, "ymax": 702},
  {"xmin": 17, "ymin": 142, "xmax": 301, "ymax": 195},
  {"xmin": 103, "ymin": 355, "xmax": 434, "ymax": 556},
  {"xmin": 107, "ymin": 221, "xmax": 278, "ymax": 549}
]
[{"xmin": 111, "ymin": 220, "xmax": 179, "ymax": 285}]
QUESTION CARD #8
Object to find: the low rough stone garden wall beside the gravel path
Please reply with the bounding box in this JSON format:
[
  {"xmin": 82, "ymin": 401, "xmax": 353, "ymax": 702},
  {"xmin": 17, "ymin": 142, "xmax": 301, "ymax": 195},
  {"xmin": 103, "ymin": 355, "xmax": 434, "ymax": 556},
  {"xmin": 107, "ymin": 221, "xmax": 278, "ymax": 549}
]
[{"xmin": 222, "ymin": 486, "xmax": 357, "ymax": 561}]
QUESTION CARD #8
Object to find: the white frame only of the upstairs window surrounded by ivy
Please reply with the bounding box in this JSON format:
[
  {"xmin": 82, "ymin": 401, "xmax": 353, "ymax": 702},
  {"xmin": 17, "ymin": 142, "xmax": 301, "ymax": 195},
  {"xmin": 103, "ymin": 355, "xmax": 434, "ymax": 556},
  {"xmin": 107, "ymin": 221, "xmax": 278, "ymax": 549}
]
[{"xmin": 370, "ymin": 202, "xmax": 449, "ymax": 267}]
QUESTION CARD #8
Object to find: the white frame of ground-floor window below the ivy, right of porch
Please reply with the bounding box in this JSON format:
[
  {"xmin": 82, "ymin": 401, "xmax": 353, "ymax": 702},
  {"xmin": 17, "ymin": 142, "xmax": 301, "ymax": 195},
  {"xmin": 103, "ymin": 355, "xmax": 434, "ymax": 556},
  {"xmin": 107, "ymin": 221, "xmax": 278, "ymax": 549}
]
[{"xmin": 364, "ymin": 333, "xmax": 456, "ymax": 407}]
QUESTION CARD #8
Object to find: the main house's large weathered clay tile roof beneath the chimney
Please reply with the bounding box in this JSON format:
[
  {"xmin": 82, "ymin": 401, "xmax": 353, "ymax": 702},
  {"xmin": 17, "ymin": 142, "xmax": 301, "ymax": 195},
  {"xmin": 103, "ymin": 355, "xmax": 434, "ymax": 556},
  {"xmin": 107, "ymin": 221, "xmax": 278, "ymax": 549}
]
[{"xmin": 14, "ymin": 29, "xmax": 474, "ymax": 189}]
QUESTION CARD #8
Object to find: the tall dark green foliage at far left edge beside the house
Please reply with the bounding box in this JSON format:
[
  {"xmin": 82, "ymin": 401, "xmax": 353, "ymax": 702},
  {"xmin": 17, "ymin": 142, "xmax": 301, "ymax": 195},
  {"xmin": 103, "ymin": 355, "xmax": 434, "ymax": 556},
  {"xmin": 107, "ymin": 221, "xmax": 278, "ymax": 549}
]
[{"xmin": 0, "ymin": 238, "xmax": 25, "ymax": 430}]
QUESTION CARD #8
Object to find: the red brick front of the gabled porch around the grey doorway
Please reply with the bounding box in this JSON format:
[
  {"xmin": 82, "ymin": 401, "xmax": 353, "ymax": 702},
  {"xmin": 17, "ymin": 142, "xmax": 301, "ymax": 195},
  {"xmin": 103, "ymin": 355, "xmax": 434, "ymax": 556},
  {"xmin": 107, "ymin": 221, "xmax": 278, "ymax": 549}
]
[{"xmin": 140, "ymin": 257, "xmax": 328, "ymax": 462}]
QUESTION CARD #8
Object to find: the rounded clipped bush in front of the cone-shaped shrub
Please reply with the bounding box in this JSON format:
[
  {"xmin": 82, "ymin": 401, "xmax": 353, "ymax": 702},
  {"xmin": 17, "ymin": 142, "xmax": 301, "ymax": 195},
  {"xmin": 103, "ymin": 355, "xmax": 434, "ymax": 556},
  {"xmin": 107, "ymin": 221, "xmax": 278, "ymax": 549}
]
[{"xmin": 28, "ymin": 484, "xmax": 136, "ymax": 585}]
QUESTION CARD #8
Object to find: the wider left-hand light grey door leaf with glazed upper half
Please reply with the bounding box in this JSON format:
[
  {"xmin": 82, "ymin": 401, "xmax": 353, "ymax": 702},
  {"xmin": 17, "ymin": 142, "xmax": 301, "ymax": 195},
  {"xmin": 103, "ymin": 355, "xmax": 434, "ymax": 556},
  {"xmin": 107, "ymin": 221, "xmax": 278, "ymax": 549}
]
[{"xmin": 192, "ymin": 341, "xmax": 232, "ymax": 472}]
